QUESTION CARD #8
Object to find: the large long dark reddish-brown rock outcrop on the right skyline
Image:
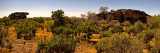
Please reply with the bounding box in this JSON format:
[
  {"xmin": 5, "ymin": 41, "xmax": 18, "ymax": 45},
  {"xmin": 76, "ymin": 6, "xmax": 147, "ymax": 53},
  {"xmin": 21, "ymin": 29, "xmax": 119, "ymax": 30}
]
[{"xmin": 97, "ymin": 9, "xmax": 149, "ymax": 24}]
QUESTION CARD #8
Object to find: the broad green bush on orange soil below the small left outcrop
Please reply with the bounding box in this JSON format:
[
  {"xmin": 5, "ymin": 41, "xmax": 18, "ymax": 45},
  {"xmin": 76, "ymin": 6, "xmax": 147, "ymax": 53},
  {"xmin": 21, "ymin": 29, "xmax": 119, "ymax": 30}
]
[{"xmin": 14, "ymin": 20, "xmax": 39, "ymax": 40}]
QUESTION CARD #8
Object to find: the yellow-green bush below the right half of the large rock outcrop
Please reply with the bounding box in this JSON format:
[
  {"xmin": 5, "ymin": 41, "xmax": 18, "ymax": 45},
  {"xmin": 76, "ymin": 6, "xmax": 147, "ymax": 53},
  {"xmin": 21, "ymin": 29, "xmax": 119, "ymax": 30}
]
[{"xmin": 125, "ymin": 21, "xmax": 146, "ymax": 33}]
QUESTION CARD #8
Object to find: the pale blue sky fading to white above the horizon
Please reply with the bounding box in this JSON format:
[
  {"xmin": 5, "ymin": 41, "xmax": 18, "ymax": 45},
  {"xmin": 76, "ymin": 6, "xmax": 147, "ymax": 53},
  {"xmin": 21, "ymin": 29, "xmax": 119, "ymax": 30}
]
[{"xmin": 0, "ymin": 0, "xmax": 160, "ymax": 18}]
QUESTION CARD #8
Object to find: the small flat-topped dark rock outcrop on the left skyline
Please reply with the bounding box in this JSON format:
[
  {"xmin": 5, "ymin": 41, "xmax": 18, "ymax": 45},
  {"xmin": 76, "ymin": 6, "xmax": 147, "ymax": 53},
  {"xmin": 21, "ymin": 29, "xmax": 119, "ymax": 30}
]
[{"xmin": 8, "ymin": 12, "xmax": 29, "ymax": 20}]
